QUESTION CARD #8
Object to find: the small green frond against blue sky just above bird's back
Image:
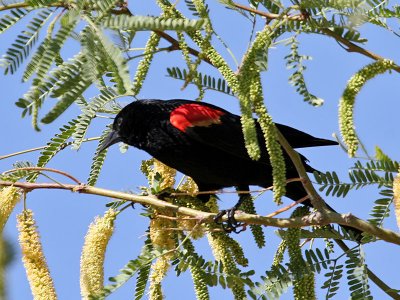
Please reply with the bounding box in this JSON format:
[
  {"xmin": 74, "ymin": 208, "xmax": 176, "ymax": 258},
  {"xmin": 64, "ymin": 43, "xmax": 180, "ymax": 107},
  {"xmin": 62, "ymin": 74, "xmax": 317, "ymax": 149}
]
[{"xmin": 167, "ymin": 67, "xmax": 234, "ymax": 96}]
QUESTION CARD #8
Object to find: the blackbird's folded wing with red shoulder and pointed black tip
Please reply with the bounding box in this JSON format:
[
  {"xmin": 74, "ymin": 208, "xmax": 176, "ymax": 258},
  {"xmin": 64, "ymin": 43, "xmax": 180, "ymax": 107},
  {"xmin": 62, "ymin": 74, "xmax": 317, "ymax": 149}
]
[{"xmin": 169, "ymin": 102, "xmax": 337, "ymax": 163}]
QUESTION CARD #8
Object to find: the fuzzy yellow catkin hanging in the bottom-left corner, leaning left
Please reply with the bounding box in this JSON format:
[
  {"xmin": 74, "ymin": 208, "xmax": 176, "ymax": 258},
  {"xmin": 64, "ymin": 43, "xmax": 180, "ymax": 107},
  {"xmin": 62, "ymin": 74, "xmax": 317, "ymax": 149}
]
[{"xmin": 17, "ymin": 210, "xmax": 57, "ymax": 300}]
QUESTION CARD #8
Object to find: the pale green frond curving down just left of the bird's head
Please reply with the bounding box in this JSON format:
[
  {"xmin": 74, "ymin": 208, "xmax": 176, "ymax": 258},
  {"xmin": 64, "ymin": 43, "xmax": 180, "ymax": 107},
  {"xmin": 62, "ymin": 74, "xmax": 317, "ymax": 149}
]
[{"xmin": 72, "ymin": 88, "xmax": 118, "ymax": 150}]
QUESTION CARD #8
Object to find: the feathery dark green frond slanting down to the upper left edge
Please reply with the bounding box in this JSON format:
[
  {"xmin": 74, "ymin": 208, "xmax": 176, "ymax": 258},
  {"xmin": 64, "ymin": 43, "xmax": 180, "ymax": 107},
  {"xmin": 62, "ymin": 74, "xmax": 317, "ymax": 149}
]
[{"xmin": 0, "ymin": 9, "xmax": 54, "ymax": 74}]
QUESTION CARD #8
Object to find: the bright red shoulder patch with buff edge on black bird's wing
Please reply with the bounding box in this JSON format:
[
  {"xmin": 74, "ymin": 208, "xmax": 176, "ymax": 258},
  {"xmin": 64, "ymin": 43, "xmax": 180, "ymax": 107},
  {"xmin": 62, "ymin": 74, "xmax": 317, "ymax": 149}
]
[{"xmin": 169, "ymin": 103, "xmax": 225, "ymax": 132}]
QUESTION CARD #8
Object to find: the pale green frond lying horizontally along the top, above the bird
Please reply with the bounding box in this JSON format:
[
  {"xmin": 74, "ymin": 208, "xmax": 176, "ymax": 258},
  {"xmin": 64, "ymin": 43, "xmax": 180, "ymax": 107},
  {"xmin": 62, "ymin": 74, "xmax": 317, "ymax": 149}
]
[{"xmin": 102, "ymin": 15, "xmax": 206, "ymax": 31}]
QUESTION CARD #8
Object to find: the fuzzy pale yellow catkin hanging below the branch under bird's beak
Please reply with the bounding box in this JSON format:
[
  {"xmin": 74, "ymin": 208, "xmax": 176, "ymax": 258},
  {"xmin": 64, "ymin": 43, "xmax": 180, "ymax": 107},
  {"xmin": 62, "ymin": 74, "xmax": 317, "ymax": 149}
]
[{"xmin": 80, "ymin": 209, "xmax": 118, "ymax": 299}]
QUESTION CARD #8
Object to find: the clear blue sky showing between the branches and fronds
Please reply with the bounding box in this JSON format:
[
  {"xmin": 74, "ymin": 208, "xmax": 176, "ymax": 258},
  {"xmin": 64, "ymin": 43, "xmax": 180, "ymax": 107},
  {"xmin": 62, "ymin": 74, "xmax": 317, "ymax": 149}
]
[{"xmin": 0, "ymin": 1, "xmax": 400, "ymax": 299}]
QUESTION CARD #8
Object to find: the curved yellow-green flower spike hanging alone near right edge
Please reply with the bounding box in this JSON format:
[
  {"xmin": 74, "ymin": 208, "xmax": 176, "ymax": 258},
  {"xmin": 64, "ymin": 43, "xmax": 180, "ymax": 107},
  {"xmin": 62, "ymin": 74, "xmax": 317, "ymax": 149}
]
[{"xmin": 339, "ymin": 59, "xmax": 394, "ymax": 157}]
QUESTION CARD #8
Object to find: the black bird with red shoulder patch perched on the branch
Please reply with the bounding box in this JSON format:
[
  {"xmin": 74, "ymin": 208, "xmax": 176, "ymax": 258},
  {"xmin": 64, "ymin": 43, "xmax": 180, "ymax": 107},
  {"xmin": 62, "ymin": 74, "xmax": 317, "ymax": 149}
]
[{"xmin": 101, "ymin": 99, "xmax": 360, "ymax": 238}]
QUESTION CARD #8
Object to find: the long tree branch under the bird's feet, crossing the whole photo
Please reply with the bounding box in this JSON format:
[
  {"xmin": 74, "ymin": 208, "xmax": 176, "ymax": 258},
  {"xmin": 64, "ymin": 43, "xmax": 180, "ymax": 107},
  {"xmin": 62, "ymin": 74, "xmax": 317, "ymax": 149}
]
[{"xmin": 0, "ymin": 181, "xmax": 400, "ymax": 245}]
